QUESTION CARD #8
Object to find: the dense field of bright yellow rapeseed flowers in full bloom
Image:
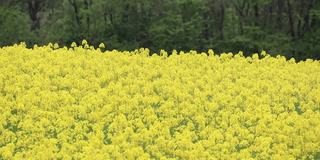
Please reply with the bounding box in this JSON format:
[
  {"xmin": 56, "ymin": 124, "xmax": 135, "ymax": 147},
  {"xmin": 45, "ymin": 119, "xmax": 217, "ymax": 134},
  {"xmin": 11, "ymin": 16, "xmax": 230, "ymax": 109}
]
[{"xmin": 0, "ymin": 41, "xmax": 320, "ymax": 160}]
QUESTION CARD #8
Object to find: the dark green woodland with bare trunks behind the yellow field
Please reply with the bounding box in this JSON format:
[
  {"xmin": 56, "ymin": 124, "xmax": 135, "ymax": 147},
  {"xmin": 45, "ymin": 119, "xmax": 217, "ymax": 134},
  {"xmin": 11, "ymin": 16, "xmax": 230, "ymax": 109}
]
[{"xmin": 0, "ymin": 0, "xmax": 320, "ymax": 59}]
